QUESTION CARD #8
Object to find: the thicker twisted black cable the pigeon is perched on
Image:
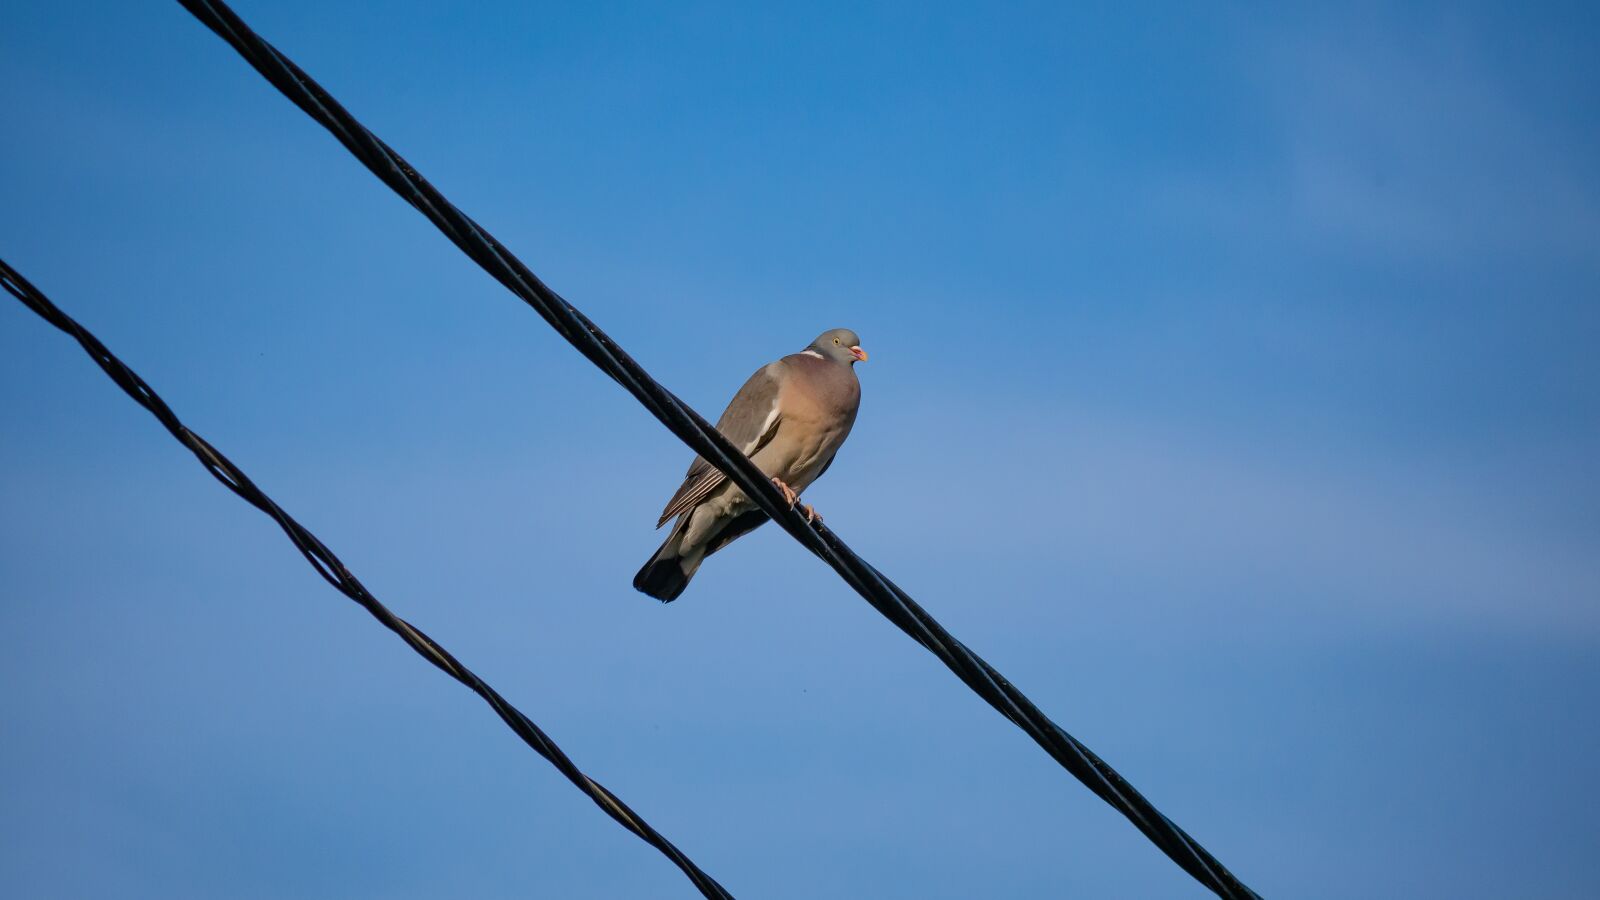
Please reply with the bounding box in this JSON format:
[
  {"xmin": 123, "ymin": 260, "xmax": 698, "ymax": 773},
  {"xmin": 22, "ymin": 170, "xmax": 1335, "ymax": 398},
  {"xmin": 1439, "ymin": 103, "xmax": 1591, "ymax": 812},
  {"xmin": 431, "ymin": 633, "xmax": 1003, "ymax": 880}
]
[{"xmin": 179, "ymin": 0, "xmax": 1256, "ymax": 898}]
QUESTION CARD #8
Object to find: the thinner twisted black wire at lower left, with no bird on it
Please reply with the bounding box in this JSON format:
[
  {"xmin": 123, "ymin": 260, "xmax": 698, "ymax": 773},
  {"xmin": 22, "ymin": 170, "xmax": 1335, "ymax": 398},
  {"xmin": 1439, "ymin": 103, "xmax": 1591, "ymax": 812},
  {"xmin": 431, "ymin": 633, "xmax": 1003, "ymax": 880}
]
[{"xmin": 0, "ymin": 259, "xmax": 733, "ymax": 900}]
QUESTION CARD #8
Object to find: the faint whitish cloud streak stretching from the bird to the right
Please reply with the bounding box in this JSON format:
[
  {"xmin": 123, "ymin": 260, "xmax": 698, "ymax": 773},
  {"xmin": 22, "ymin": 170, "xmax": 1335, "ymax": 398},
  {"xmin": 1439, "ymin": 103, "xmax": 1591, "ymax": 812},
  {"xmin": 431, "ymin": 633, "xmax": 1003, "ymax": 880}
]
[{"xmin": 830, "ymin": 403, "xmax": 1600, "ymax": 637}]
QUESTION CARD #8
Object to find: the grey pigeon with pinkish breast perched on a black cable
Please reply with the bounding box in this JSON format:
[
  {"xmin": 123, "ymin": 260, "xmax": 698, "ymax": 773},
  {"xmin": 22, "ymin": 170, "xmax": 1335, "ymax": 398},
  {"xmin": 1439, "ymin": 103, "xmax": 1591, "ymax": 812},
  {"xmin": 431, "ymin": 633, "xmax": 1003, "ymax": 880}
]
[{"xmin": 634, "ymin": 328, "xmax": 867, "ymax": 602}]
